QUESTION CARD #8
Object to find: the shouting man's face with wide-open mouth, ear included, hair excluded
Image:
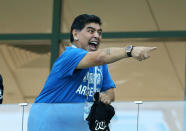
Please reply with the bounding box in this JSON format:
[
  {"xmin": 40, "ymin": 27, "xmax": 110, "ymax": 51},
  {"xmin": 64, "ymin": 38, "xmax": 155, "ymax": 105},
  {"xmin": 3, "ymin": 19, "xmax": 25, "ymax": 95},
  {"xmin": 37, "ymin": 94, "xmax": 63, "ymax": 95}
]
[{"xmin": 77, "ymin": 23, "xmax": 102, "ymax": 51}]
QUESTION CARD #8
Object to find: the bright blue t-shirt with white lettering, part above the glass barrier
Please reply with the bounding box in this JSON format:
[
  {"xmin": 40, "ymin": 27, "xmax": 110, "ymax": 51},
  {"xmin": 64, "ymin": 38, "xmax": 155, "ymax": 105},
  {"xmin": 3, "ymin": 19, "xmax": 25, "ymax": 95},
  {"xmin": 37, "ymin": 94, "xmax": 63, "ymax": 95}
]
[{"xmin": 35, "ymin": 47, "xmax": 115, "ymax": 103}]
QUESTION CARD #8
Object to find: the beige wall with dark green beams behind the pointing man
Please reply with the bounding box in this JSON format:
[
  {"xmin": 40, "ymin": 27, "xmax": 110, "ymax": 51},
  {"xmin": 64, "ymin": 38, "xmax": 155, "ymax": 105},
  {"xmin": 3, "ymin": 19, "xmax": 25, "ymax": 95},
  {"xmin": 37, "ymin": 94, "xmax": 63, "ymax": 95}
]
[{"xmin": 0, "ymin": 0, "xmax": 186, "ymax": 104}]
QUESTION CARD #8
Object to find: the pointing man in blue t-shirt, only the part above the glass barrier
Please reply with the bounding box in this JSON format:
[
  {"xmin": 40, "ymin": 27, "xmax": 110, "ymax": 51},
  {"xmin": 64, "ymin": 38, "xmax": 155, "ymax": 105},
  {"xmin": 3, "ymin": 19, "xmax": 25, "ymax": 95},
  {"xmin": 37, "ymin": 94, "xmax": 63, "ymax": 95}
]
[{"xmin": 35, "ymin": 14, "xmax": 156, "ymax": 104}]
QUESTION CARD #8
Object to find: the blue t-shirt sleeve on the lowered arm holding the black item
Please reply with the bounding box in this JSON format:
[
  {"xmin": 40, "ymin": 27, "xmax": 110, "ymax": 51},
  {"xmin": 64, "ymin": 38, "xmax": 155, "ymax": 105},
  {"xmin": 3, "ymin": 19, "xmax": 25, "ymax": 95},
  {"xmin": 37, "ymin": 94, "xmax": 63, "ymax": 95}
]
[{"xmin": 101, "ymin": 65, "xmax": 116, "ymax": 91}]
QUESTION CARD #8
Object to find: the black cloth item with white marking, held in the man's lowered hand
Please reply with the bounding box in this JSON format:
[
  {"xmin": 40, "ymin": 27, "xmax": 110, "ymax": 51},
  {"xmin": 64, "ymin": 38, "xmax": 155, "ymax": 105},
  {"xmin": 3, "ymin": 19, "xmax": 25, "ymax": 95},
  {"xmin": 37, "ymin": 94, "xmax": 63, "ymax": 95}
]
[{"xmin": 86, "ymin": 92, "xmax": 115, "ymax": 131}]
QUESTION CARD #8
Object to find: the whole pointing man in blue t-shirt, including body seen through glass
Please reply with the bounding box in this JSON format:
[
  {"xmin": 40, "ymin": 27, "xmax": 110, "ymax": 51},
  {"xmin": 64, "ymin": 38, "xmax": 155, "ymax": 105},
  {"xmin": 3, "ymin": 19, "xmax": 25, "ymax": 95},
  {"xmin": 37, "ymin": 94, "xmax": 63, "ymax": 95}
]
[{"xmin": 28, "ymin": 14, "xmax": 156, "ymax": 131}]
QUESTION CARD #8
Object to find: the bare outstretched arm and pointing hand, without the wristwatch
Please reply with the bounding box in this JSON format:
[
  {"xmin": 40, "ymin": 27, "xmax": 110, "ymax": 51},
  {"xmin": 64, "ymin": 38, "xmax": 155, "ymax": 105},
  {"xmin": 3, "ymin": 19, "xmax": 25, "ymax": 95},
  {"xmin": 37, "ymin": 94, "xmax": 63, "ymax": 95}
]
[{"xmin": 76, "ymin": 47, "xmax": 156, "ymax": 69}]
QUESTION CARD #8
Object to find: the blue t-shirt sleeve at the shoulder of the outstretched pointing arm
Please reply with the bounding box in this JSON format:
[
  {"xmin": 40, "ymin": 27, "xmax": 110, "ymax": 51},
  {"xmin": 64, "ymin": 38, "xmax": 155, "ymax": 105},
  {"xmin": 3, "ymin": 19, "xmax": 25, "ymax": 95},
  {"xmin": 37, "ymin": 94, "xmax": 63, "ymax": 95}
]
[{"xmin": 51, "ymin": 47, "xmax": 88, "ymax": 77}]
